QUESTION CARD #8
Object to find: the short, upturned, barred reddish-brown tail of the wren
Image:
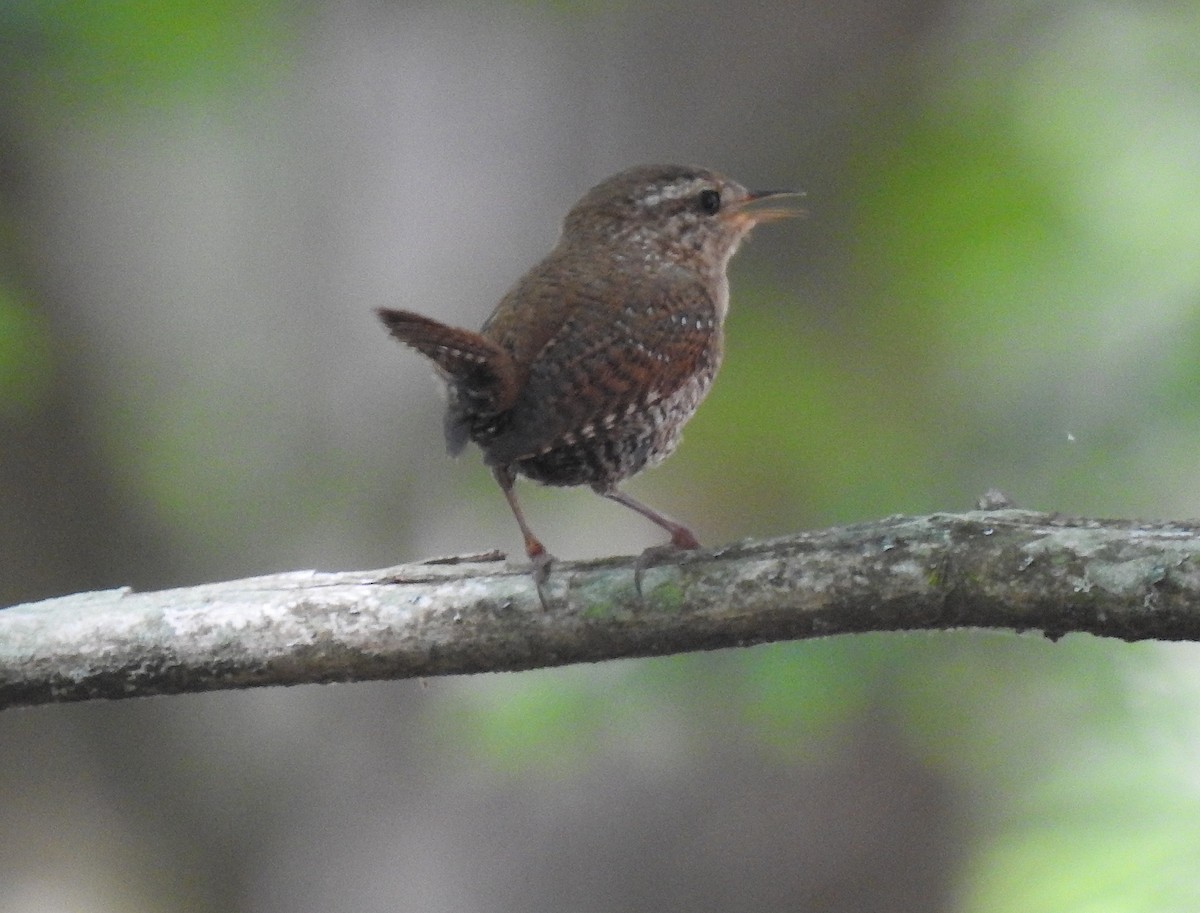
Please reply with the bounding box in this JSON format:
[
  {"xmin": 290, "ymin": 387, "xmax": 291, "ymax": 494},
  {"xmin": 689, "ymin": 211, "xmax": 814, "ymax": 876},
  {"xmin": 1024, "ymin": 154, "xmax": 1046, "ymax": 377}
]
[{"xmin": 376, "ymin": 307, "xmax": 517, "ymax": 414}]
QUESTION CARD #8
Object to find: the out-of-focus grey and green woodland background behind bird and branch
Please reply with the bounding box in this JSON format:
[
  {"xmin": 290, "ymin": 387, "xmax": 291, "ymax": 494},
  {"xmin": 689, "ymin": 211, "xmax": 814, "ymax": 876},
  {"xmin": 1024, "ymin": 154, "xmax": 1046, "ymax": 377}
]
[{"xmin": 0, "ymin": 0, "xmax": 1200, "ymax": 913}]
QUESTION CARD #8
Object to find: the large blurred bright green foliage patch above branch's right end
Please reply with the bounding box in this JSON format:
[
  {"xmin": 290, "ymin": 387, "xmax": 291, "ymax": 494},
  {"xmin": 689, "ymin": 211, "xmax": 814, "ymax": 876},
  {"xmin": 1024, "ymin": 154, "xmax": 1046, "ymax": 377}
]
[{"xmin": 852, "ymin": 5, "xmax": 1200, "ymax": 513}]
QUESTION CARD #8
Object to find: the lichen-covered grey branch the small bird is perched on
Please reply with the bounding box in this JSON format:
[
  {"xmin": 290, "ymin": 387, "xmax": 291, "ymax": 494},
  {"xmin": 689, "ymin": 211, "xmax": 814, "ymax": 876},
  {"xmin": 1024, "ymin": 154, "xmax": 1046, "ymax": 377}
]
[{"xmin": 0, "ymin": 510, "xmax": 1200, "ymax": 708}]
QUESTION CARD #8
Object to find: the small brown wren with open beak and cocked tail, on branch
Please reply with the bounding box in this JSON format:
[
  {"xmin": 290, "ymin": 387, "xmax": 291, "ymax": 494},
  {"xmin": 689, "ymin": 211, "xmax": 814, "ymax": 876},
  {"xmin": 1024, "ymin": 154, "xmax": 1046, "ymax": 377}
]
[{"xmin": 378, "ymin": 164, "xmax": 796, "ymax": 590}]
